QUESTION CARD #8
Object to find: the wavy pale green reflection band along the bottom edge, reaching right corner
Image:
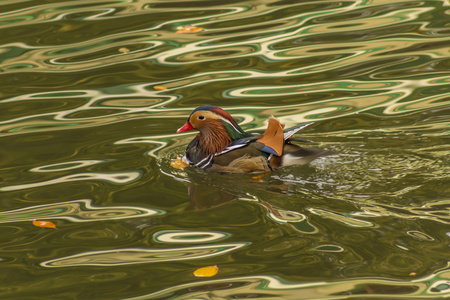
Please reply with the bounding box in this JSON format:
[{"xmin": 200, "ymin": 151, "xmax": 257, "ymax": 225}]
[{"xmin": 127, "ymin": 270, "xmax": 450, "ymax": 300}]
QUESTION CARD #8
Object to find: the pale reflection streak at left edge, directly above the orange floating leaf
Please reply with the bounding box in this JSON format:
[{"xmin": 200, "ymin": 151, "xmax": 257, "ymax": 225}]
[{"xmin": 0, "ymin": 199, "xmax": 165, "ymax": 223}]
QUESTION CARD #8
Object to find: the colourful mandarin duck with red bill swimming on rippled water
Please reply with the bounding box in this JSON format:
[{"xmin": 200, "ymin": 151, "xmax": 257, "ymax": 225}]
[{"xmin": 177, "ymin": 105, "xmax": 331, "ymax": 173}]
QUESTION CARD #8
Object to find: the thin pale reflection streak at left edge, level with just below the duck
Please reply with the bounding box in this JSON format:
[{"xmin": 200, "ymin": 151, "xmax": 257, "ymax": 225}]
[{"xmin": 0, "ymin": 171, "xmax": 141, "ymax": 192}]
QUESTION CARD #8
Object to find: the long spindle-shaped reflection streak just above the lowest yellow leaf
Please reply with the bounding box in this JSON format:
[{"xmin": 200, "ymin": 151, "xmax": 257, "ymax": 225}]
[{"xmin": 41, "ymin": 243, "xmax": 248, "ymax": 268}]
